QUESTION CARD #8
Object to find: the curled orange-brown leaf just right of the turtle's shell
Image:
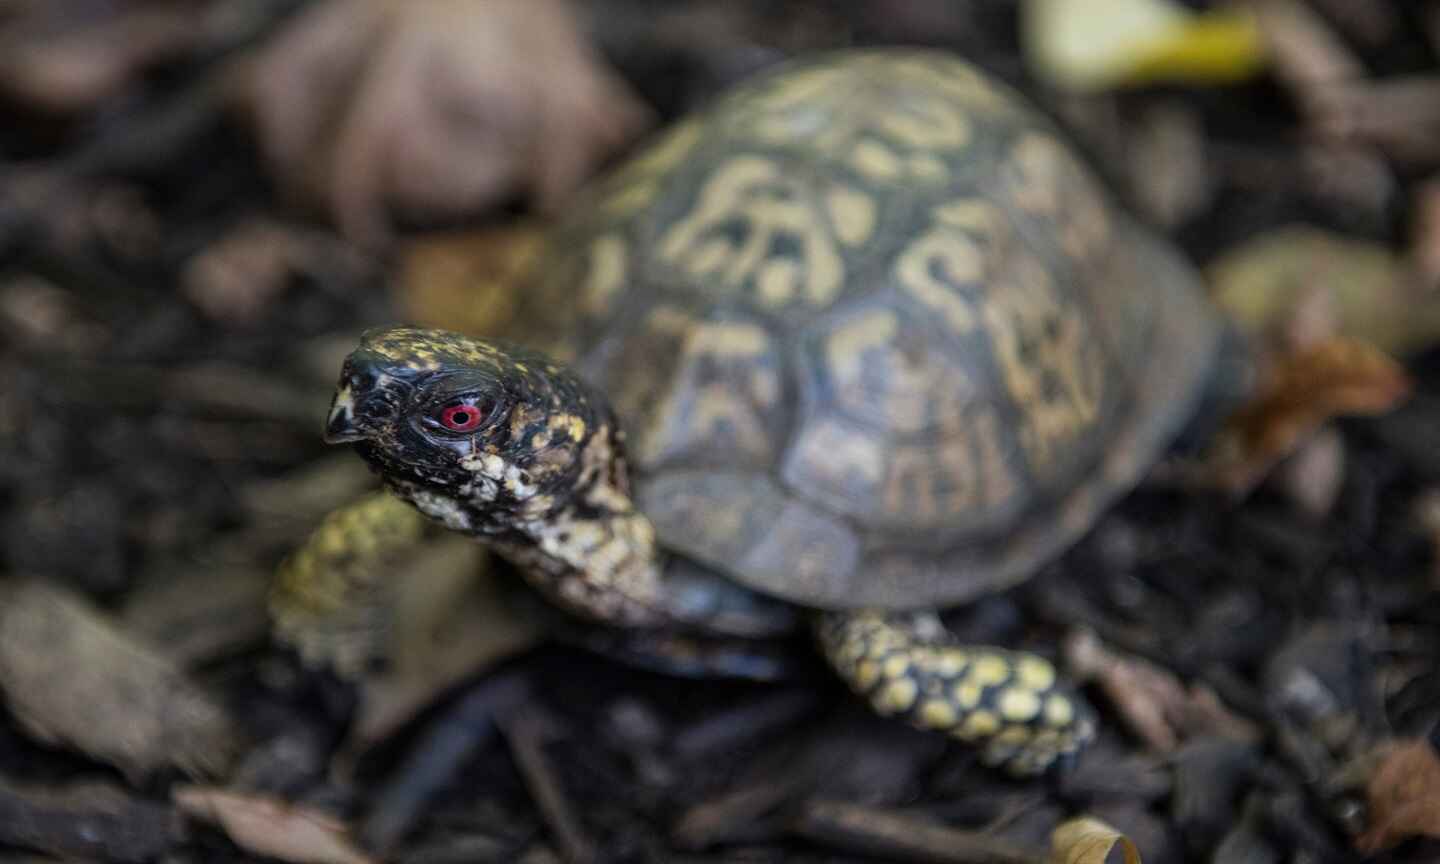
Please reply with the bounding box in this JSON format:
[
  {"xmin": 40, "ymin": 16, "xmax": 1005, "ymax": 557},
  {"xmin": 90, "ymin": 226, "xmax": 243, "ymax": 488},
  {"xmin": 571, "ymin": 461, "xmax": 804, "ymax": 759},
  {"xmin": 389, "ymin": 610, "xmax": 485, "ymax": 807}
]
[{"xmin": 1202, "ymin": 338, "xmax": 1411, "ymax": 494}]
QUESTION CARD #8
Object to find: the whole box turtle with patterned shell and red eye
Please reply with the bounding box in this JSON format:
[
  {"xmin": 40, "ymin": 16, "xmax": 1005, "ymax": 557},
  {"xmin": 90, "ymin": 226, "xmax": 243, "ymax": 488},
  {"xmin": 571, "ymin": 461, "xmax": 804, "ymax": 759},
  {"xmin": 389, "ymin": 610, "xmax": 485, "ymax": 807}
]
[{"xmin": 275, "ymin": 48, "xmax": 1224, "ymax": 775}]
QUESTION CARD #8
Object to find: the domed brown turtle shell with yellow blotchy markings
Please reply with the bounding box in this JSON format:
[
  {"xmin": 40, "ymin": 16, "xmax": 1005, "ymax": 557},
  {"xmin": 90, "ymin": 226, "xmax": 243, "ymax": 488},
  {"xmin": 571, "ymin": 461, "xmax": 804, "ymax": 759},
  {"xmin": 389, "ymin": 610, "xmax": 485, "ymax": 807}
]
[{"xmin": 507, "ymin": 49, "xmax": 1218, "ymax": 608}]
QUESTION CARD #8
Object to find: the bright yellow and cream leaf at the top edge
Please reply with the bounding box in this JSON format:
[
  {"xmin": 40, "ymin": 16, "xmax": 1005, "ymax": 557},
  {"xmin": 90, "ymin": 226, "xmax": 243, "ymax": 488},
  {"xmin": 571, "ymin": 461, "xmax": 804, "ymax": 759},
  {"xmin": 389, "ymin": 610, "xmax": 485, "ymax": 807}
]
[{"xmin": 1022, "ymin": 0, "xmax": 1264, "ymax": 91}]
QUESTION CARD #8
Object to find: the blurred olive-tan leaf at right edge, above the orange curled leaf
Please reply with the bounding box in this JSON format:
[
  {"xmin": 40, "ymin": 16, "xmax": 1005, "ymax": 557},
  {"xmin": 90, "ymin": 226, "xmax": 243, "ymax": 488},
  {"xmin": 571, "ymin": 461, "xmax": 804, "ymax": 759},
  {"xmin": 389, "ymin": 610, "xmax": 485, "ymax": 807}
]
[{"xmin": 1207, "ymin": 226, "xmax": 1440, "ymax": 356}]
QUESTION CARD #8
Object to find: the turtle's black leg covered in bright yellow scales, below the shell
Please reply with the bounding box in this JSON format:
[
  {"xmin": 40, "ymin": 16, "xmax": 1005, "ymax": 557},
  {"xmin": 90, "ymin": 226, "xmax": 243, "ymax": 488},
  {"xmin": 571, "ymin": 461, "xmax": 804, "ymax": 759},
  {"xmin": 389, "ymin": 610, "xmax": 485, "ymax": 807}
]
[{"xmin": 816, "ymin": 611, "xmax": 1094, "ymax": 775}]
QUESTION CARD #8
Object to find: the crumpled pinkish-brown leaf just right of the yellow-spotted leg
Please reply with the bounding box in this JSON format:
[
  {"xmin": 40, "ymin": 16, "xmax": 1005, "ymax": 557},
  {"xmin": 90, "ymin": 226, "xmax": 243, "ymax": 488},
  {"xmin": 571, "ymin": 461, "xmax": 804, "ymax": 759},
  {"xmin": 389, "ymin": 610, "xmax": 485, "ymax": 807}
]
[{"xmin": 1064, "ymin": 631, "xmax": 1260, "ymax": 753}]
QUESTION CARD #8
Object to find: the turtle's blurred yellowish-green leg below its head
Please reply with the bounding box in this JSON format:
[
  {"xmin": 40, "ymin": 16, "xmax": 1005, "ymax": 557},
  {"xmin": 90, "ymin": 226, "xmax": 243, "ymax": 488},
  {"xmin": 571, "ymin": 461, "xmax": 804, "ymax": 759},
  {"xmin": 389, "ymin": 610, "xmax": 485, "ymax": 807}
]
[{"xmin": 269, "ymin": 492, "xmax": 426, "ymax": 678}]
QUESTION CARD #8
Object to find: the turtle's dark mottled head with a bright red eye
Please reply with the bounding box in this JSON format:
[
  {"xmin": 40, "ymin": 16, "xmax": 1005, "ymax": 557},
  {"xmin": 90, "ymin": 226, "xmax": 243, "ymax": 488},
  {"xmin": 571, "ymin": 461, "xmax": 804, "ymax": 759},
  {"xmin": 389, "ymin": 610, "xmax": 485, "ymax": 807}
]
[{"xmin": 325, "ymin": 327, "xmax": 613, "ymax": 530}]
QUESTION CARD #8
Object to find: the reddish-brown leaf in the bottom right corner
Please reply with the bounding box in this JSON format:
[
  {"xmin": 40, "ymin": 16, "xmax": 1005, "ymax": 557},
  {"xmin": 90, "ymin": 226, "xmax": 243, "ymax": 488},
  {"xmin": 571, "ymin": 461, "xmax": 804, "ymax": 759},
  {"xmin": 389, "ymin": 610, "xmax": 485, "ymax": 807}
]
[{"xmin": 1355, "ymin": 739, "xmax": 1440, "ymax": 854}]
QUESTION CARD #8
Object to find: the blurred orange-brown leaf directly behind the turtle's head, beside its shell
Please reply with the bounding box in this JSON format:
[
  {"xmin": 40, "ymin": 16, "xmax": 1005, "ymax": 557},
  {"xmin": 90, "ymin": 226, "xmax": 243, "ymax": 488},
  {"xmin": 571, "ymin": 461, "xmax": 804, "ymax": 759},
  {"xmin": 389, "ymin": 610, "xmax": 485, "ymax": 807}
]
[{"xmin": 397, "ymin": 222, "xmax": 544, "ymax": 336}]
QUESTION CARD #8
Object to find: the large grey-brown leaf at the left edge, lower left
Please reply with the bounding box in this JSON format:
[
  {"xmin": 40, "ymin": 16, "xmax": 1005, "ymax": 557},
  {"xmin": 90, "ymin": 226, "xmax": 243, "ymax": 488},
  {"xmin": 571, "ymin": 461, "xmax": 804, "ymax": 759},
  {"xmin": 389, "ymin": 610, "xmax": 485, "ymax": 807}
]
[{"xmin": 0, "ymin": 582, "xmax": 236, "ymax": 780}]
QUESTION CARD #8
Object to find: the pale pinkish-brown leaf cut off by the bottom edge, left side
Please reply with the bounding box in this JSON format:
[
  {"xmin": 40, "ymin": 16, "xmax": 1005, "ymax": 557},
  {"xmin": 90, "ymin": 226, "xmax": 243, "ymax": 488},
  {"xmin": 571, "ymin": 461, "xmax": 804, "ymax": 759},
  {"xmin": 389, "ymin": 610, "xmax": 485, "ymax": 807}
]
[{"xmin": 174, "ymin": 786, "xmax": 376, "ymax": 864}]
